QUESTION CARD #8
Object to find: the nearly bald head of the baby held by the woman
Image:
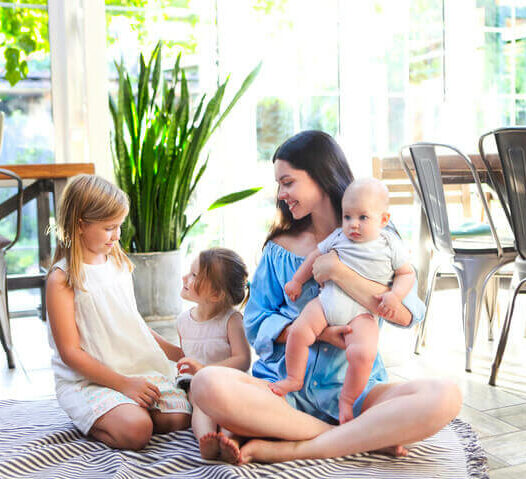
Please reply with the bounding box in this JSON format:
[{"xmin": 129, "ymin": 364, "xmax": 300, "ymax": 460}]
[{"xmin": 342, "ymin": 178, "xmax": 390, "ymax": 243}]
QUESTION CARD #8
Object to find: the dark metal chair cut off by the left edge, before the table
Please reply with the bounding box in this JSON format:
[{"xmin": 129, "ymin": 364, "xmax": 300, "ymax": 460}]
[{"xmin": 0, "ymin": 112, "xmax": 23, "ymax": 369}]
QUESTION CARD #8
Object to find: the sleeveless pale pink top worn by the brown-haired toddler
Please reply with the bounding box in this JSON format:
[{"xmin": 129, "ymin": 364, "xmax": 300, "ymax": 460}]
[{"xmin": 176, "ymin": 309, "xmax": 235, "ymax": 365}]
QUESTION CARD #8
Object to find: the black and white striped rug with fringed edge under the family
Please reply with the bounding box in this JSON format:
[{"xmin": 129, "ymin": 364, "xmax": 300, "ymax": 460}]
[{"xmin": 0, "ymin": 400, "xmax": 488, "ymax": 479}]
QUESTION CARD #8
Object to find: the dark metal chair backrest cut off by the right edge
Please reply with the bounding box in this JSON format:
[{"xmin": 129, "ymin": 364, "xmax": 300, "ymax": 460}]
[{"xmin": 479, "ymin": 127, "xmax": 526, "ymax": 259}]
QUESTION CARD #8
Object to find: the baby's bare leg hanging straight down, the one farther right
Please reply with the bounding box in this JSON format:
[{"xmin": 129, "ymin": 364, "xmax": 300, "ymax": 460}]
[{"xmin": 339, "ymin": 314, "xmax": 378, "ymax": 424}]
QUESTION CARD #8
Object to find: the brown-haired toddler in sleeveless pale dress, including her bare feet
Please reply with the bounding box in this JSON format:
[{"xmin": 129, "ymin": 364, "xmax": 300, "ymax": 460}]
[{"xmin": 177, "ymin": 248, "xmax": 250, "ymax": 463}]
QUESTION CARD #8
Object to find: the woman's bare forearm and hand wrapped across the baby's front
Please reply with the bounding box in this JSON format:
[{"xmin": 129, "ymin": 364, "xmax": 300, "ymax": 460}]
[{"xmin": 312, "ymin": 251, "xmax": 412, "ymax": 326}]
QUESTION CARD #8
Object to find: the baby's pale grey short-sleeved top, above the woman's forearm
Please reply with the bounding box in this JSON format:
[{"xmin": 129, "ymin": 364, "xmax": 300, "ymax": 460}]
[{"xmin": 318, "ymin": 228, "xmax": 409, "ymax": 285}]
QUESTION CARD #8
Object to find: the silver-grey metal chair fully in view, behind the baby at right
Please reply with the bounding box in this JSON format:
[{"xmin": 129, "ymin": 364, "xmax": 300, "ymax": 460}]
[{"xmin": 400, "ymin": 143, "xmax": 517, "ymax": 372}]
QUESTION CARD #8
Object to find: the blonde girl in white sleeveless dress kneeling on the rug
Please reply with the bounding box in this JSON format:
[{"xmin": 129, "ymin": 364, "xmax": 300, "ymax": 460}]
[{"xmin": 46, "ymin": 175, "xmax": 191, "ymax": 450}]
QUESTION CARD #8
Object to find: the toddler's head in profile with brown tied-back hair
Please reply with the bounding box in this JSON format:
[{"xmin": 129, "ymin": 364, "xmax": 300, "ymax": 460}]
[{"xmin": 181, "ymin": 248, "xmax": 248, "ymax": 308}]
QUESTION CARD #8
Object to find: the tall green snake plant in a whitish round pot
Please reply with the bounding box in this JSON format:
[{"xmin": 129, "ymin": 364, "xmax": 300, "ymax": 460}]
[{"xmin": 109, "ymin": 43, "xmax": 260, "ymax": 320}]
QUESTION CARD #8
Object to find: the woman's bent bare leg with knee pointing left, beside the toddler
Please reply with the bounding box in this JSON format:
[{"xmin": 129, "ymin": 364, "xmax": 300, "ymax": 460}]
[{"xmin": 191, "ymin": 366, "xmax": 331, "ymax": 441}]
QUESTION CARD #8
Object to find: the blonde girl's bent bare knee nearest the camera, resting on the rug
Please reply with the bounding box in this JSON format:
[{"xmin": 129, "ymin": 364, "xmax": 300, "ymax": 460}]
[{"xmin": 89, "ymin": 404, "xmax": 153, "ymax": 451}]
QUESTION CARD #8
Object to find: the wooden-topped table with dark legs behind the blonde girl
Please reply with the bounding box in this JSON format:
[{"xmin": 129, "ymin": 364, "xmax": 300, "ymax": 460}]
[{"xmin": 0, "ymin": 163, "xmax": 95, "ymax": 317}]
